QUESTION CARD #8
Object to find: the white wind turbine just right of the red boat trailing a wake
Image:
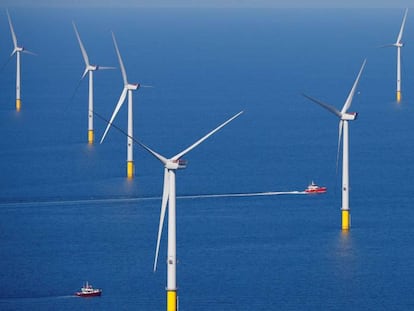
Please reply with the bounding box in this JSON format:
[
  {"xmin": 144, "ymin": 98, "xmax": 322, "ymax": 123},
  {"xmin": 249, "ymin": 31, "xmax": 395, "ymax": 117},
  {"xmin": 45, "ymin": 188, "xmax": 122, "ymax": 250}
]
[{"xmin": 303, "ymin": 60, "xmax": 366, "ymax": 230}]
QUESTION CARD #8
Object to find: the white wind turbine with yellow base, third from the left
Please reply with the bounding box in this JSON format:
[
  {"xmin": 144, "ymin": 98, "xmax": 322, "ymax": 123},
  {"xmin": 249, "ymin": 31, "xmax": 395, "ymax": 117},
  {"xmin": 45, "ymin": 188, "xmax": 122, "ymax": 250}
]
[{"xmin": 101, "ymin": 33, "xmax": 140, "ymax": 178}]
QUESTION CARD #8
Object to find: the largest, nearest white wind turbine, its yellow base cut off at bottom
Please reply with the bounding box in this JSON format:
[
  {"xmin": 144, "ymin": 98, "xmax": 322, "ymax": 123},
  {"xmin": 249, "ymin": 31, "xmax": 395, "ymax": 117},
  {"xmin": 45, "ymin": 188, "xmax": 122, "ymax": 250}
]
[{"xmin": 136, "ymin": 111, "xmax": 243, "ymax": 311}]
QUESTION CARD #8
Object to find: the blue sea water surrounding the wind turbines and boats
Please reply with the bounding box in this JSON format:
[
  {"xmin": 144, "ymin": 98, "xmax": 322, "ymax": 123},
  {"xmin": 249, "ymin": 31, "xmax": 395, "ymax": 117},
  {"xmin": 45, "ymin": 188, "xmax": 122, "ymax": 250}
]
[{"xmin": 0, "ymin": 9, "xmax": 414, "ymax": 311}]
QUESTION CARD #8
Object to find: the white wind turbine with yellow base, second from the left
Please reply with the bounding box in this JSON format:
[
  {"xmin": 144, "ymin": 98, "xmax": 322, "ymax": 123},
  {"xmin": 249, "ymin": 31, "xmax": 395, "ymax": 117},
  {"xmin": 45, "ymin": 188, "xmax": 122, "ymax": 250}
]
[{"xmin": 72, "ymin": 22, "xmax": 115, "ymax": 144}]
